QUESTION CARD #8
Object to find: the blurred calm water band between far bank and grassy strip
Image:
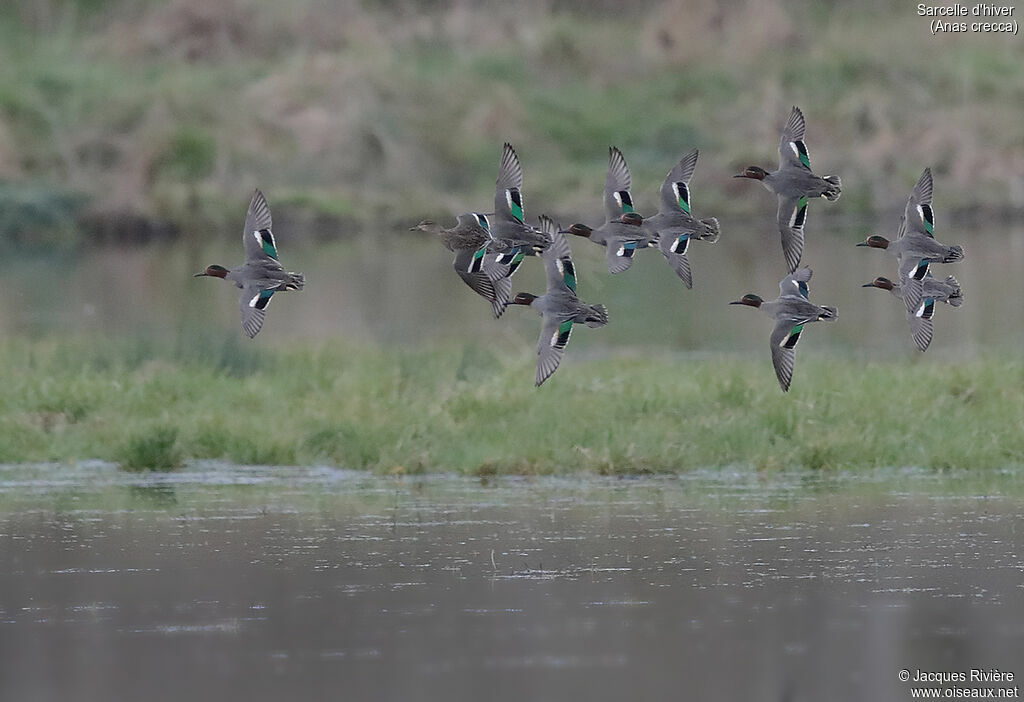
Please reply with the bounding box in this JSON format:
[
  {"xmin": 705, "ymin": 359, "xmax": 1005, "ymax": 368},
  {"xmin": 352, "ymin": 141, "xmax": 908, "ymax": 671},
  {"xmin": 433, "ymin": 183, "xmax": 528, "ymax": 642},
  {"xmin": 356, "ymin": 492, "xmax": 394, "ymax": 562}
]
[{"xmin": 0, "ymin": 220, "xmax": 1024, "ymax": 358}]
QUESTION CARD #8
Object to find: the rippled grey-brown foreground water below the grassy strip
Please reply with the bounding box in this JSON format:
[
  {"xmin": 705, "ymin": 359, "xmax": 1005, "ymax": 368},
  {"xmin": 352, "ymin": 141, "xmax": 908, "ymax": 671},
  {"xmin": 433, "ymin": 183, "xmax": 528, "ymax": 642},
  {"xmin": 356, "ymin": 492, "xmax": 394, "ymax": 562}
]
[{"xmin": 0, "ymin": 465, "xmax": 1024, "ymax": 702}]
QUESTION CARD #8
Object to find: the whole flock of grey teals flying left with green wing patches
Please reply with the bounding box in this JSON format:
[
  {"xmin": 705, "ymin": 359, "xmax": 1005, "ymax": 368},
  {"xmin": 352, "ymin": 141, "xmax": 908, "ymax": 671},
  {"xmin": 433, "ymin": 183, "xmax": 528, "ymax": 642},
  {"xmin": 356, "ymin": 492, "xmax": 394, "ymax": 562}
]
[{"xmin": 197, "ymin": 107, "xmax": 964, "ymax": 391}]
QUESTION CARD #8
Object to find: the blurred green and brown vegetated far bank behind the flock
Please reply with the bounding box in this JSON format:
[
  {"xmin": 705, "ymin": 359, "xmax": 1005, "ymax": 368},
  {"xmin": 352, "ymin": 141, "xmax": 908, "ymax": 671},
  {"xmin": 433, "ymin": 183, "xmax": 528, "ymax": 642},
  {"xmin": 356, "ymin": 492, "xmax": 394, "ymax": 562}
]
[{"xmin": 0, "ymin": 0, "xmax": 1024, "ymax": 247}]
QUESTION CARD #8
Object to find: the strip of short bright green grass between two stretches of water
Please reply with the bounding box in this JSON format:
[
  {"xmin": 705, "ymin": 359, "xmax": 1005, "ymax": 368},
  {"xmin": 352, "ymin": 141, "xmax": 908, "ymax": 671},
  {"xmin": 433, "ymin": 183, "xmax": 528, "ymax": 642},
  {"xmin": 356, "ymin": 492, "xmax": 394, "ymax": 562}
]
[{"xmin": 0, "ymin": 341, "xmax": 1024, "ymax": 475}]
